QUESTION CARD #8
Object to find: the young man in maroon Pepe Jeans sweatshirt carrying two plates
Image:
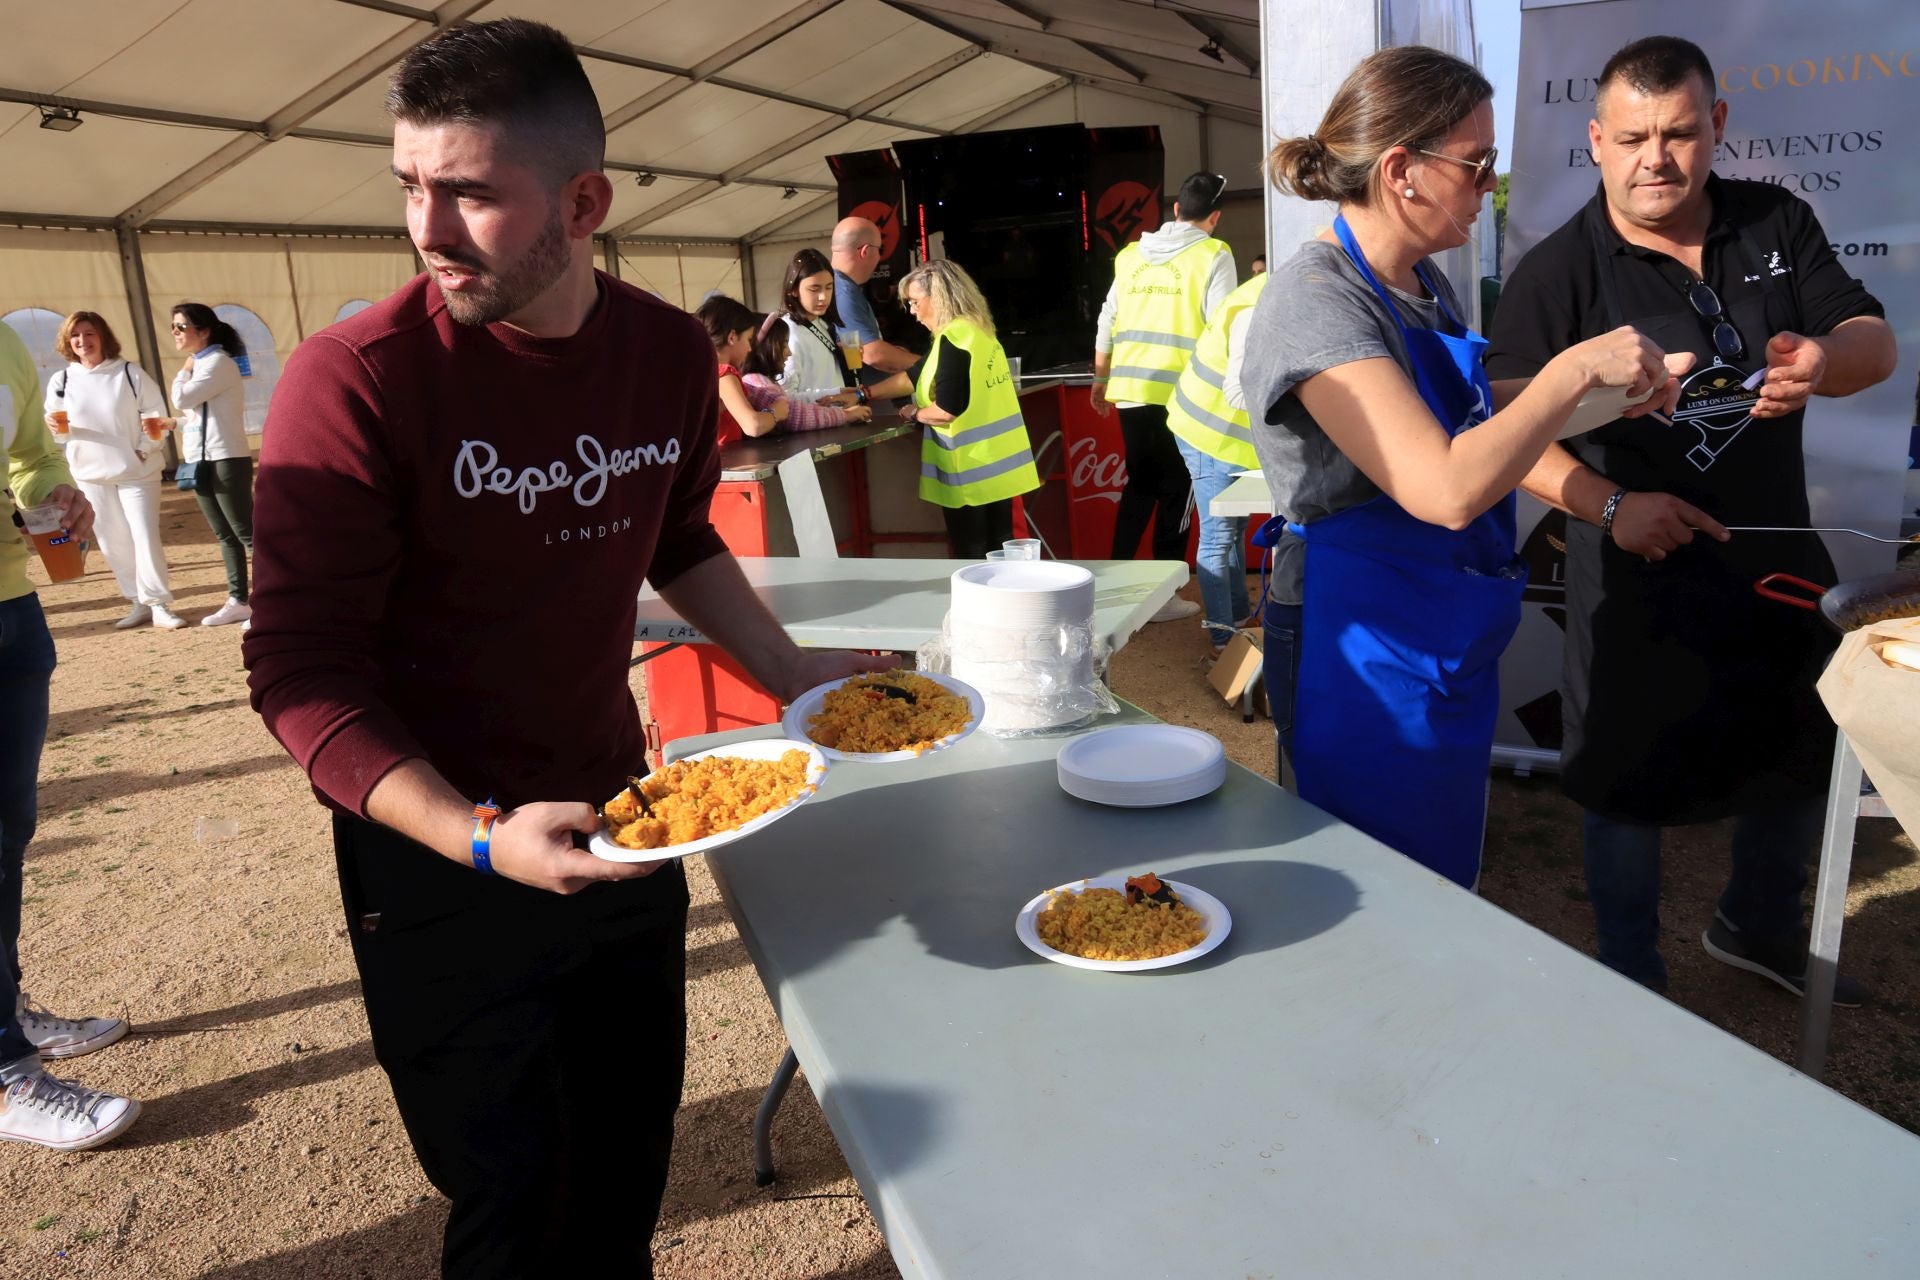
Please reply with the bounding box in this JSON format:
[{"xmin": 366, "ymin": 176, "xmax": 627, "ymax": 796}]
[{"xmin": 246, "ymin": 19, "xmax": 876, "ymax": 1276}]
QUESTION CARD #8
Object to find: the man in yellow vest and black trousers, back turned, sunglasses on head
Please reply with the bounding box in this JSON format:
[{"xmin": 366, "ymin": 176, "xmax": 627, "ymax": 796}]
[{"xmin": 1089, "ymin": 173, "xmax": 1236, "ymax": 622}]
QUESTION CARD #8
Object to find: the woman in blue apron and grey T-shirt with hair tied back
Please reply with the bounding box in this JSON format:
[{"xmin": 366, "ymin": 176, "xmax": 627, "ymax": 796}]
[{"xmin": 1242, "ymin": 46, "xmax": 1678, "ymax": 887}]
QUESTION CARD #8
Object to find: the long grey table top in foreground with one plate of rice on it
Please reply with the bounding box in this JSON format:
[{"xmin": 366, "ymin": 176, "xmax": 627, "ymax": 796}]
[{"xmin": 698, "ymin": 712, "xmax": 1920, "ymax": 1280}]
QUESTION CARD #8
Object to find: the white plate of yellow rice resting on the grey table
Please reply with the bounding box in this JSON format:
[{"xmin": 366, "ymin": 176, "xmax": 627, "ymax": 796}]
[{"xmin": 1014, "ymin": 871, "xmax": 1233, "ymax": 973}]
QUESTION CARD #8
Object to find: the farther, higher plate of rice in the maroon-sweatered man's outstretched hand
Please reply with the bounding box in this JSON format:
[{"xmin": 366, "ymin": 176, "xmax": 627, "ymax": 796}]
[{"xmin": 780, "ymin": 668, "xmax": 987, "ymax": 764}]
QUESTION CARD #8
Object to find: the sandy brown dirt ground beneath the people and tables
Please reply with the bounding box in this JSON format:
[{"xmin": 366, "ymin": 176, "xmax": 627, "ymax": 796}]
[{"xmin": 0, "ymin": 489, "xmax": 1920, "ymax": 1280}]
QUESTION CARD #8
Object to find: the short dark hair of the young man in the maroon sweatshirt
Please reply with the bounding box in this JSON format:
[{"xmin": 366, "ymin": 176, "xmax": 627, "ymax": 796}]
[{"xmin": 386, "ymin": 17, "xmax": 607, "ymax": 182}]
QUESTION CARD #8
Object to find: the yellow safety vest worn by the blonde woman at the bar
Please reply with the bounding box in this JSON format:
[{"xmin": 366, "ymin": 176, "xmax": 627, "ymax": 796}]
[{"xmin": 914, "ymin": 320, "xmax": 1041, "ymax": 507}]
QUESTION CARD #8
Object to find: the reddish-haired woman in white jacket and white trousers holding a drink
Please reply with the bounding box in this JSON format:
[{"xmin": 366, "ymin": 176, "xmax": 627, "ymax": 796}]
[{"xmin": 46, "ymin": 311, "xmax": 186, "ymax": 631}]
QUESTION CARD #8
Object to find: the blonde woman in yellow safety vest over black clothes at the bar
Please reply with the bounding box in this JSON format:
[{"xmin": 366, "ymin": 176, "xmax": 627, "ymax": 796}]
[{"xmin": 900, "ymin": 257, "xmax": 1041, "ymax": 560}]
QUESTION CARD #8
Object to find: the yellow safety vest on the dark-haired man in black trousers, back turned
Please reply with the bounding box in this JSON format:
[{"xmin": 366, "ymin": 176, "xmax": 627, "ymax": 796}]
[{"xmin": 1106, "ymin": 236, "xmax": 1229, "ymax": 405}]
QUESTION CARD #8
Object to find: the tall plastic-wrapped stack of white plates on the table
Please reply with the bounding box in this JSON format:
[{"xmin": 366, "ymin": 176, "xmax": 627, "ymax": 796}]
[{"xmin": 947, "ymin": 560, "xmax": 1102, "ymax": 735}]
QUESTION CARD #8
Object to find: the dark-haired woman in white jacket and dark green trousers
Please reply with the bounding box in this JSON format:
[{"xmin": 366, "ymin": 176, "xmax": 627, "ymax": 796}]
[{"xmin": 171, "ymin": 301, "xmax": 253, "ymax": 628}]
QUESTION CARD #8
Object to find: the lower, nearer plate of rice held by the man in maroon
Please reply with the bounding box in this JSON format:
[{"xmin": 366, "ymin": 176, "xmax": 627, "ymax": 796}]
[{"xmin": 588, "ymin": 739, "xmax": 828, "ymax": 862}]
